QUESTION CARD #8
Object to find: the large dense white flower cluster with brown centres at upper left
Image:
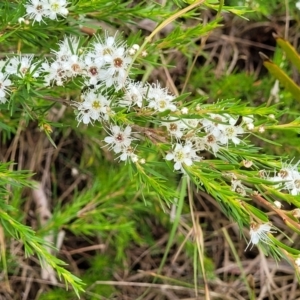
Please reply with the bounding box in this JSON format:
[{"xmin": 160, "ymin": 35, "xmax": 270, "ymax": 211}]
[{"xmin": 42, "ymin": 34, "xmax": 132, "ymax": 91}]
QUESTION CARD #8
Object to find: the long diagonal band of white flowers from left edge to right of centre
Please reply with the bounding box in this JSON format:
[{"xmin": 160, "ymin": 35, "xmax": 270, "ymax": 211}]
[{"xmin": 0, "ymin": 32, "xmax": 254, "ymax": 172}]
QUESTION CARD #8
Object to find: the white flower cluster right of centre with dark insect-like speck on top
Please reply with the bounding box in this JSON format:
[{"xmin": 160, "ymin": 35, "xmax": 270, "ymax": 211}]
[{"xmin": 162, "ymin": 113, "xmax": 254, "ymax": 171}]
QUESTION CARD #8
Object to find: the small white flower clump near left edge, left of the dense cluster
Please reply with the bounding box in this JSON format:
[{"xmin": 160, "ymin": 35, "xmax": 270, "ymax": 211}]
[{"xmin": 5, "ymin": 55, "xmax": 39, "ymax": 78}]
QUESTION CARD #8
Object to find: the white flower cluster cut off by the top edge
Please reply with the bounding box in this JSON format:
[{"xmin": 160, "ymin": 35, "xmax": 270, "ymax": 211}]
[{"xmin": 25, "ymin": 0, "xmax": 69, "ymax": 23}]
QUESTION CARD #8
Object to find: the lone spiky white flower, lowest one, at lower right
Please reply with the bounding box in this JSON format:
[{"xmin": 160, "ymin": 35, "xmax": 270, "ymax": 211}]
[{"xmin": 245, "ymin": 222, "xmax": 276, "ymax": 251}]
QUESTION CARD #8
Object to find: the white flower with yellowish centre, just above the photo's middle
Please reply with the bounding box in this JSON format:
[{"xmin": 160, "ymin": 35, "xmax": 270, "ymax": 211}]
[{"xmin": 147, "ymin": 83, "xmax": 176, "ymax": 112}]
